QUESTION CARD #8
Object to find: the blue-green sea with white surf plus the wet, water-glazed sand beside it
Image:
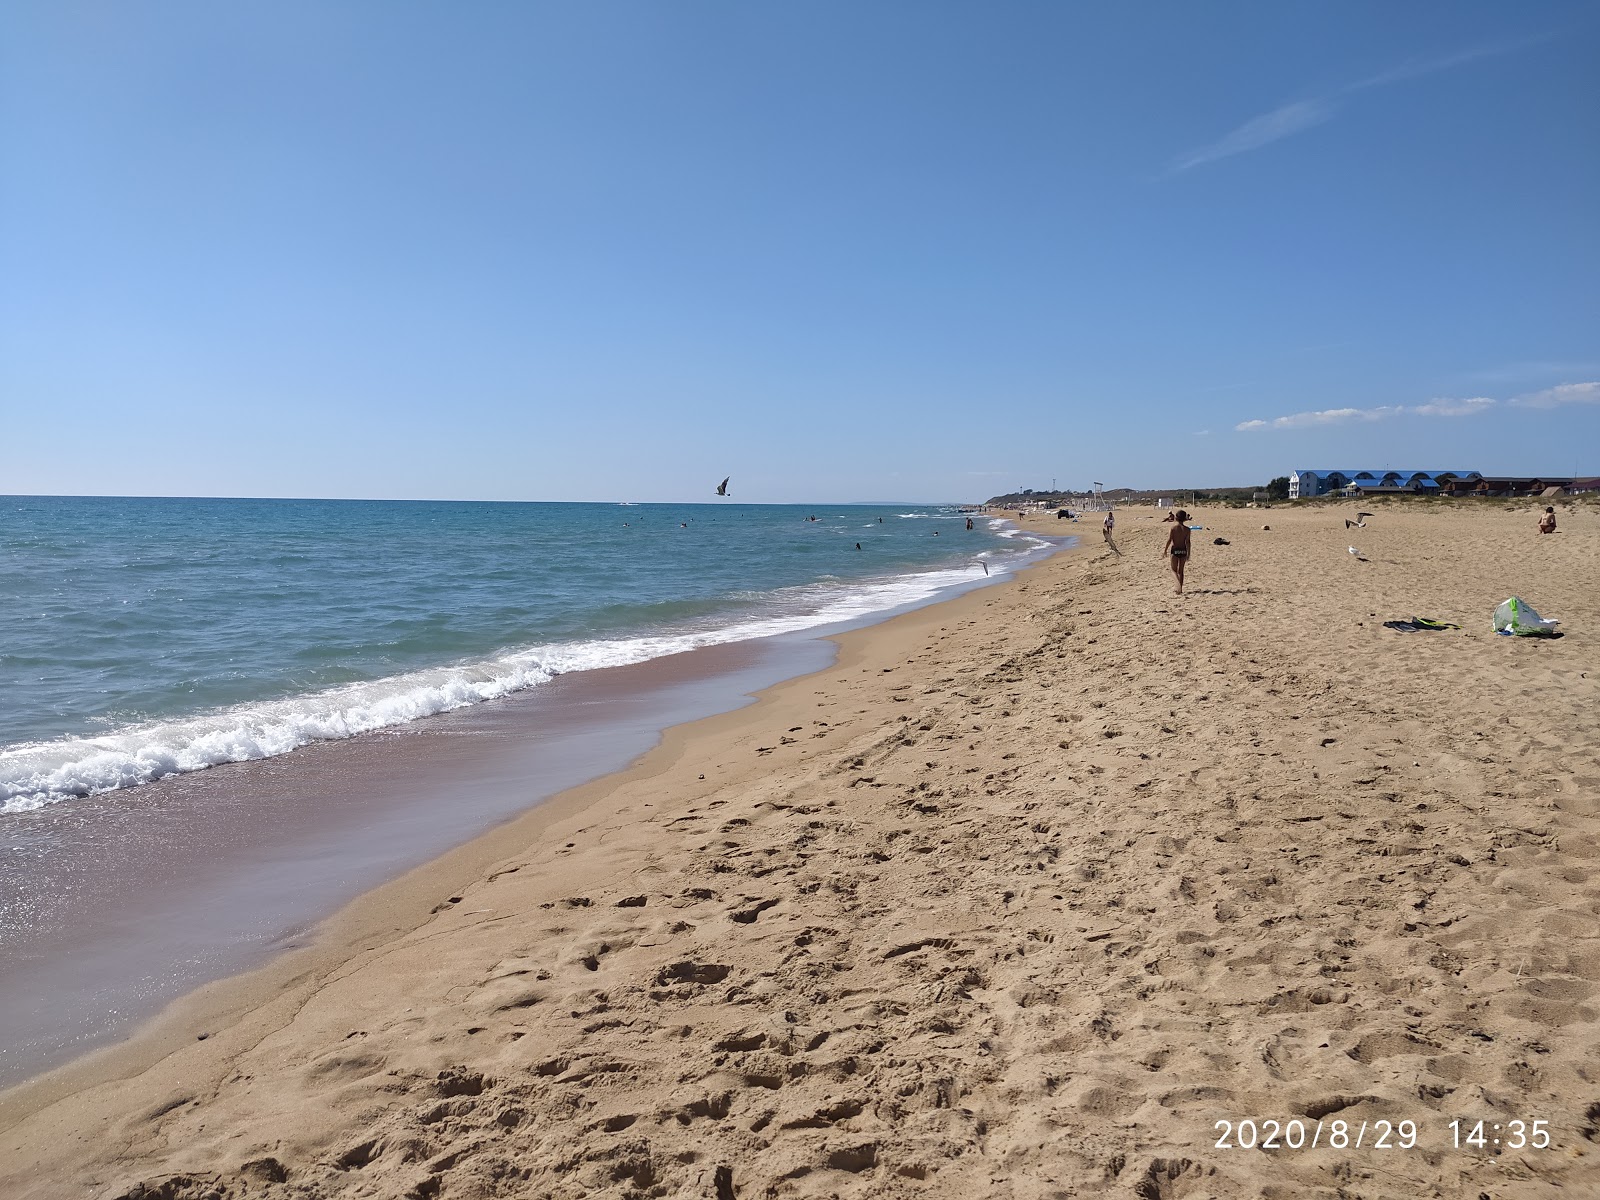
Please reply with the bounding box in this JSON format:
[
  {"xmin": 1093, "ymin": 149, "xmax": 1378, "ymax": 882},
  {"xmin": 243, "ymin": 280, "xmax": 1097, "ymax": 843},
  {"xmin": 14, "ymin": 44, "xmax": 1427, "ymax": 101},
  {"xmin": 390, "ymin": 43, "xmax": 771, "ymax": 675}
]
[{"xmin": 0, "ymin": 496, "xmax": 1059, "ymax": 1085}]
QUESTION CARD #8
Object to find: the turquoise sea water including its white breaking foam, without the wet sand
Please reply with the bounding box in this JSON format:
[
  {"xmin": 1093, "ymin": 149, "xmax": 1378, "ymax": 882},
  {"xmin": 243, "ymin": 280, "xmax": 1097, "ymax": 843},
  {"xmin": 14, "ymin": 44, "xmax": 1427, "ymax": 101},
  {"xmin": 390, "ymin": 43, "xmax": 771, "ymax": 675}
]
[{"xmin": 0, "ymin": 498, "xmax": 1040, "ymax": 811}]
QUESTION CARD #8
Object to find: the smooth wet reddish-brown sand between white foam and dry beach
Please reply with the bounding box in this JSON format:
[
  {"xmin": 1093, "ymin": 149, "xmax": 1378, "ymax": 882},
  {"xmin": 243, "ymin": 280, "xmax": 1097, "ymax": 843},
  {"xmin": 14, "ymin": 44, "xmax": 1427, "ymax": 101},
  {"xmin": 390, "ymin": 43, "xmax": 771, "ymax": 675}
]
[{"xmin": 0, "ymin": 637, "xmax": 834, "ymax": 1086}]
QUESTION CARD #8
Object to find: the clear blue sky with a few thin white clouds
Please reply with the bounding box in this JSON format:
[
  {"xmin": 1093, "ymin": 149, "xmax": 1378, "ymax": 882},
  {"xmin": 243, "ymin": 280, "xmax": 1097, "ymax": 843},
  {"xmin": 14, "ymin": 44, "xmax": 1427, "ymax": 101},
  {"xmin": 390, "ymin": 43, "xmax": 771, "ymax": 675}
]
[{"xmin": 0, "ymin": 0, "xmax": 1600, "ymax": 502}]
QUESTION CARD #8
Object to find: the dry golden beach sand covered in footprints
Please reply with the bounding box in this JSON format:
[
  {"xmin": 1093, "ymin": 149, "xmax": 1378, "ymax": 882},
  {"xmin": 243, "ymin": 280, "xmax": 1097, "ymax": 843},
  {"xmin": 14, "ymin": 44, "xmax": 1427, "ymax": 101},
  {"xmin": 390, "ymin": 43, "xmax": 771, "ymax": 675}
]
[{"xmin": 0, "ymin": 504, "xmax": 1600, "ymax": 1200}]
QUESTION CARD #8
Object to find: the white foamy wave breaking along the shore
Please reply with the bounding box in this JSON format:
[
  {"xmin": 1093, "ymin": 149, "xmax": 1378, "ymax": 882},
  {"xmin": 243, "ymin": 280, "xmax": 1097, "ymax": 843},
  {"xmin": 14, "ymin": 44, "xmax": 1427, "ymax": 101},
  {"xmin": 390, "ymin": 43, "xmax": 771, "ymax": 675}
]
[{"xmin": 0, "ymin": 560, "xmax": 1043, "ymax": 813}]
